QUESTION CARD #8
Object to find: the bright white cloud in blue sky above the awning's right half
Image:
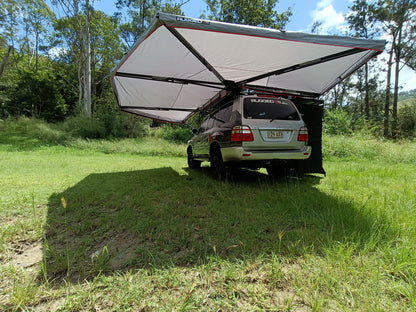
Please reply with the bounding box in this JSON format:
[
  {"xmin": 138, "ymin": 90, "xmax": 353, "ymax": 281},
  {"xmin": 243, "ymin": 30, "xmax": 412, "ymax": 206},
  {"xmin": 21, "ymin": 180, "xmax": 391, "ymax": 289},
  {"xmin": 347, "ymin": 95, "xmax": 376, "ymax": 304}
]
[{"xmin": 311, "ymin": 0, "xmax": 347, "ymax": 34}]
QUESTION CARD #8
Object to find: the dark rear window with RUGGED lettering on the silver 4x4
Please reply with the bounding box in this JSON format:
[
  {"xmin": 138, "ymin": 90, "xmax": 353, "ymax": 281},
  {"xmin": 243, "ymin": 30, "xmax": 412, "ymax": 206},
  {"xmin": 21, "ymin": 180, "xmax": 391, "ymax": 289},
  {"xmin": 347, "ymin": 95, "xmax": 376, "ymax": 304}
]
[{"xmin": 243, "ymin": 98, "xmax": 300, "ymax": 120}]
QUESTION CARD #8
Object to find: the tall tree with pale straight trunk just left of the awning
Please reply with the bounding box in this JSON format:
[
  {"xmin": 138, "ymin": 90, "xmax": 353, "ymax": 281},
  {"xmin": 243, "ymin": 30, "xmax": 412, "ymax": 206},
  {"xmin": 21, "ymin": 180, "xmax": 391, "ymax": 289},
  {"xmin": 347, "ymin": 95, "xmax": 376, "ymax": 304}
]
[{"xmin": 55, "ymin": 0, "xmax": 122, "ymax": 116}]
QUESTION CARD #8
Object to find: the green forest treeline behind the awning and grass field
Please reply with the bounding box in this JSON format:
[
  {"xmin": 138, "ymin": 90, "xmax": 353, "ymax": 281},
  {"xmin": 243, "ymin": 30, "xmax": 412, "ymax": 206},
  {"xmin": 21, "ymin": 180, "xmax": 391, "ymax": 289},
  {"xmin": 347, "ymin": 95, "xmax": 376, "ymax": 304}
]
[{"xmin": 0, "ymin": 0, "xmax": 416, "ymax": 139}]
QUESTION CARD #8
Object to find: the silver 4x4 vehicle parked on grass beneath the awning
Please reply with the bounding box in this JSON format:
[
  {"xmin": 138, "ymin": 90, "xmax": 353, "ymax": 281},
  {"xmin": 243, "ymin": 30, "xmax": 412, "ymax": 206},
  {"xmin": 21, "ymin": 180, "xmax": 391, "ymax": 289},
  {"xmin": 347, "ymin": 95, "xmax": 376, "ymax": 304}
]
[{"xmin": 187, "ymin": 95, "xmax": 311, "ymax": 179}]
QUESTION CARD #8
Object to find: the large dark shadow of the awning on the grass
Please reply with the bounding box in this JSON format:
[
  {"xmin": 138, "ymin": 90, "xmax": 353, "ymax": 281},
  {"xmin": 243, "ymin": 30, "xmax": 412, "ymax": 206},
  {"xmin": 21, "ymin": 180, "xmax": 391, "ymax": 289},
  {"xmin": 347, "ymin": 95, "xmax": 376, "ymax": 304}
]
[{"xmin": 44, "ymin": 168, "xmax": 387, "ymax": 282}]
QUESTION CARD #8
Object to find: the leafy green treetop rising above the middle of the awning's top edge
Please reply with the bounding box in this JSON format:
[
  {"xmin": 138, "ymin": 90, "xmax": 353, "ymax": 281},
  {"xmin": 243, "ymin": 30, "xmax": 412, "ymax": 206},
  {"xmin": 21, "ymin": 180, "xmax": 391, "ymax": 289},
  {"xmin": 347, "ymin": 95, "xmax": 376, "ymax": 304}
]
[{"xmin": 205, "ymin": 0, "xmax": 292, "ymax": 29}]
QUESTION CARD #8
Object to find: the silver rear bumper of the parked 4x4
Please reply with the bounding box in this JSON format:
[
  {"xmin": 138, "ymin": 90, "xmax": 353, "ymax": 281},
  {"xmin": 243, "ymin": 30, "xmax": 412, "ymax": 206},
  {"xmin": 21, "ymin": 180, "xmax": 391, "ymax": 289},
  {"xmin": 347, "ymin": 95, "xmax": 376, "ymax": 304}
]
[{"xmin": 221, "ymin": 146, "xmax": 312, "ymax": 162}]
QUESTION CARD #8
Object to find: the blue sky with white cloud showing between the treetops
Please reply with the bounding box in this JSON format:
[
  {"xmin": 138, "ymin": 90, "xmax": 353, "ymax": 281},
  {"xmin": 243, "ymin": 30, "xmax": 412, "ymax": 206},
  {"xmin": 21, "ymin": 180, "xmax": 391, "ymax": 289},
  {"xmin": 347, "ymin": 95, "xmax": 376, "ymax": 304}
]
[{"xmin": 95, "ymin": 0, "xmax": 416, "ymax": 91}]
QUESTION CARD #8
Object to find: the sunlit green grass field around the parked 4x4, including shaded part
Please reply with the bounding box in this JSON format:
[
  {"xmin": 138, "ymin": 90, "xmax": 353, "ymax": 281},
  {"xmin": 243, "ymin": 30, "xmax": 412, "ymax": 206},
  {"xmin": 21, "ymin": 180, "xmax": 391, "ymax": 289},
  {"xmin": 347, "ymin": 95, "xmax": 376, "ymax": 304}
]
[{"xmin": 0, "ymin": 119, "xmax": 416, "ymax": 311}]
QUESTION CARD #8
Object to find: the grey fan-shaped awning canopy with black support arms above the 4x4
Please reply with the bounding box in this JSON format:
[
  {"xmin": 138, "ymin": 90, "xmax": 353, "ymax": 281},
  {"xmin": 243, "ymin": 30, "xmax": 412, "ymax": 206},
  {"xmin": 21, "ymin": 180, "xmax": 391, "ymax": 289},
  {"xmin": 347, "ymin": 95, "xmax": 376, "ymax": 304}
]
[{"xmin": 112, "ymin": 13, "xmax": 385, "ymax": 123}]
